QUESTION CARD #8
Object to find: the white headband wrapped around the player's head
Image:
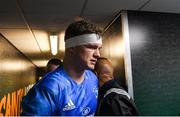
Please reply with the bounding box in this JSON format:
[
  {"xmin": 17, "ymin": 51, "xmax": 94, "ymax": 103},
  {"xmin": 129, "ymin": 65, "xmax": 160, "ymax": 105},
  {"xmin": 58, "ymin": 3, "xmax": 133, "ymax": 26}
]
[{"xmin": 65, "ymin": 33, "xmax": 102, "ymax": 48}]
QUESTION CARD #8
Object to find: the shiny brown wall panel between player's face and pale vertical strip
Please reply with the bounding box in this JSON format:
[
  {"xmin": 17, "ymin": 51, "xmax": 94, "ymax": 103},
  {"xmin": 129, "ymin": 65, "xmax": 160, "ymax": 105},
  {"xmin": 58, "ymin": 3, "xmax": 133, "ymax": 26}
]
[{"xmin": 101, "ymin": 17, "xmax": 127, "ymax": 89}]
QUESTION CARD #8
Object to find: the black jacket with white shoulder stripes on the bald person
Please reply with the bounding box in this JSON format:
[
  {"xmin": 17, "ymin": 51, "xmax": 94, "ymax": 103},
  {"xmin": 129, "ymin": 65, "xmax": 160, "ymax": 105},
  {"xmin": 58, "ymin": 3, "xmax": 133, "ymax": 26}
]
[{"xmin": 96, "ymin": 80, "xmax": 138, "ymax": 116}]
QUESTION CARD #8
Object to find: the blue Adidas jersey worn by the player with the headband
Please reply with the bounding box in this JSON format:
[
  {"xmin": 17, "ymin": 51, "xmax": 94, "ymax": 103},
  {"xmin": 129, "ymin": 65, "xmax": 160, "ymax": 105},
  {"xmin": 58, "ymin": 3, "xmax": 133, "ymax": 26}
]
[{"xmin": 21, "ymin": 68, "xmax": 98, "ymax": 116}]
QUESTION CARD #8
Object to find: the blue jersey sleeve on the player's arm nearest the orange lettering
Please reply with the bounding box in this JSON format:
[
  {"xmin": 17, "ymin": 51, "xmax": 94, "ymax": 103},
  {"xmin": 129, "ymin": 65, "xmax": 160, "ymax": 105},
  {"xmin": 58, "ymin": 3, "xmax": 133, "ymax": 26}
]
[{"xmin": 21, "ymin": 86, "xmax": 56, "ymax": 116}]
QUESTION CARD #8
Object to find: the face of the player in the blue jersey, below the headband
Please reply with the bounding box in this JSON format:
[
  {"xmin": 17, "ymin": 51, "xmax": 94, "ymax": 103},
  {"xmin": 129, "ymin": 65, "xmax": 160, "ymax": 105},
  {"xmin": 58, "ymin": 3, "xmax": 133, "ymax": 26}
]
[{"xmin": 75, "ymin": 44, "xmax": 102, "ymax": 69}]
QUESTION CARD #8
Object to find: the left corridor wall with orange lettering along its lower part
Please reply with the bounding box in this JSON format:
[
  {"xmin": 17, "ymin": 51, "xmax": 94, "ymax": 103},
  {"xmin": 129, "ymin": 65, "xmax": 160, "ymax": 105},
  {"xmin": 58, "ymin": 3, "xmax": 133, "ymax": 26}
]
[{"xmin": 0, "ymin": 34, "xmax": 36, "ymax": 116}]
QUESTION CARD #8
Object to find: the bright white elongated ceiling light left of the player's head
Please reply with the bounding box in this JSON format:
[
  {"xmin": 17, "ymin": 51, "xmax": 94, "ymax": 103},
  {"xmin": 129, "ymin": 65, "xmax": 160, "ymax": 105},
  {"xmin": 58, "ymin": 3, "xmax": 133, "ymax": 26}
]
[{"xmin": 50, "ymin": 34, "xmax": 58, "ymax": 55}]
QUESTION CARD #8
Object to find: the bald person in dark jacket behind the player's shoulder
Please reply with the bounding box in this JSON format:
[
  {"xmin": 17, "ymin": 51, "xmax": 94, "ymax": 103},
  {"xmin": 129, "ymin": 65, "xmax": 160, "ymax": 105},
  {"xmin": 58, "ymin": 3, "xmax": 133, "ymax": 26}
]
[{"xmin": 94, "ymin": 58, "xmax": 139, "ymax": 116}]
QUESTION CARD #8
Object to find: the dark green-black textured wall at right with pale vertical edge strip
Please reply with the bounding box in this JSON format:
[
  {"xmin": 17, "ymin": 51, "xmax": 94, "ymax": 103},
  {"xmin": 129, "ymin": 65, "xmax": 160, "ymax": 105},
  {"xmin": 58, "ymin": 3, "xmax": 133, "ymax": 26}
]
[{"xmin": 121, "ymin": 11, "xmax": 180, "ymax": 116}]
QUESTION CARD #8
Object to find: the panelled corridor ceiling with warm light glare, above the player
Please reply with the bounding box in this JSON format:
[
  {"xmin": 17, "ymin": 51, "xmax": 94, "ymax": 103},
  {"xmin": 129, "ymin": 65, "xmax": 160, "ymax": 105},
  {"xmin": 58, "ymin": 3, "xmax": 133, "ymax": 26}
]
[{"xmin": 0, "ymin": 0, "xmax": 180, "ymax": 67}]
